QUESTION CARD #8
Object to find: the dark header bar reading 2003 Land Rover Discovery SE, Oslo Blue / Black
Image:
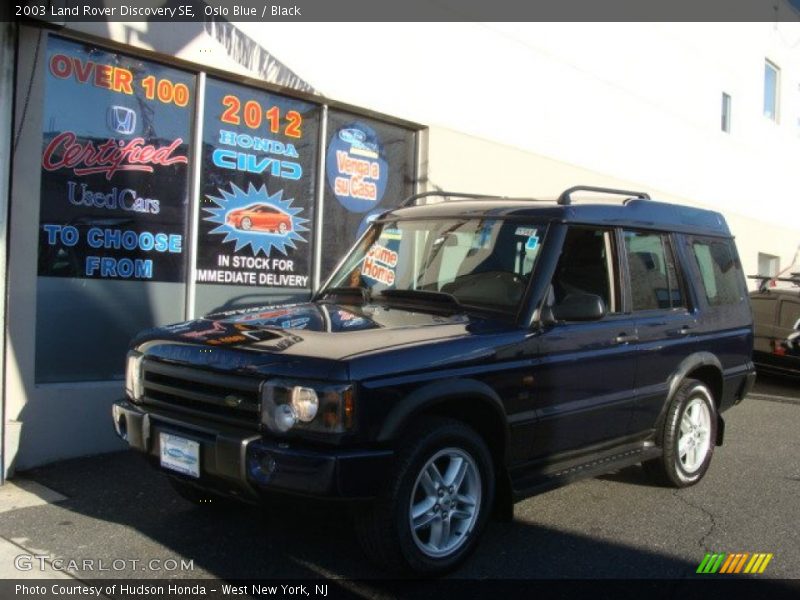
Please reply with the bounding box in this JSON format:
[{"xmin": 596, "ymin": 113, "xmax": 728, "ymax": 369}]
[{"xmin": 0, "ymin": 0, "xmax": 800, "ymax": 25}]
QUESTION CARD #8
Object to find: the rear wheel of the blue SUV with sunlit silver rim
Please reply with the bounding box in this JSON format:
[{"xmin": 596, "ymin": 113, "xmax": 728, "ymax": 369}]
[{"xmin": 642, "ymin": 379, "xmax": 717, "ymax": 488}]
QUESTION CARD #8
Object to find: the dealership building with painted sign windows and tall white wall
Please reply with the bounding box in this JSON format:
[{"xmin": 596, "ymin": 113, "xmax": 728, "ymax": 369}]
[{"xmin": 0, "ymin": 9, "xmax": 800, "ymax": 481}]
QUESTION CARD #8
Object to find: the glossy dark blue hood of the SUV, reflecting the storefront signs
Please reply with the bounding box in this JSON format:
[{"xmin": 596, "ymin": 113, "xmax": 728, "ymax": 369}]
[{"xmin": 132, "ymin": 302, "xmax": 513, "ymax": 379}]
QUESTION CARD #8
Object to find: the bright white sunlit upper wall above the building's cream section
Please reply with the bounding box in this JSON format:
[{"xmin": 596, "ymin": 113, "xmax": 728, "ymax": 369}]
[{"xmin": 236, "ymin": 22, "xmax": 800, "ymax": 270}]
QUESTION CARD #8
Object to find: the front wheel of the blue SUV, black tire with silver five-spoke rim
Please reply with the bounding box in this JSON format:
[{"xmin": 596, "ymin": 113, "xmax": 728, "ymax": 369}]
[{"xmin": 355, "ymin": 418, "xmax": 495, "ymax": 575}]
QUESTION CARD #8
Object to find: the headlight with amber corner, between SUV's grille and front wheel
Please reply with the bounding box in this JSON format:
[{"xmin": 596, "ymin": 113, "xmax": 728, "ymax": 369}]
[{"xmin": 261, "ymin": 379, "xmax": 354, "ymax": 433}]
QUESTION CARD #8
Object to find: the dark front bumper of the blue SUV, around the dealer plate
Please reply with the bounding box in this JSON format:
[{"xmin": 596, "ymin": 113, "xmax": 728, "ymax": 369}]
[{"xmin": 112, "ymin": 400, "xmax": 393, "ymax": 502}]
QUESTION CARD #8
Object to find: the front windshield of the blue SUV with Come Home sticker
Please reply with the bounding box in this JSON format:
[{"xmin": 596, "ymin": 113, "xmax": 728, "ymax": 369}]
[{"xmin": 321, "ymin": 218, "xmax": 546, "ymax": 312}]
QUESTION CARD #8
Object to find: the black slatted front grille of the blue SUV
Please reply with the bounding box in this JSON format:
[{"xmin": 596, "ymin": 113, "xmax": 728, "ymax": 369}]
[{"xmin": 142, "ymin": 360, "xmax": 261, "ymax": 429}]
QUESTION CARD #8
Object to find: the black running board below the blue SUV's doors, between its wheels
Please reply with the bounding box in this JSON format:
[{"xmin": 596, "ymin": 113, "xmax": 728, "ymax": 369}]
[{"xmin": 513, "ymin": 442, "xmax": 661, "ymax": 502}]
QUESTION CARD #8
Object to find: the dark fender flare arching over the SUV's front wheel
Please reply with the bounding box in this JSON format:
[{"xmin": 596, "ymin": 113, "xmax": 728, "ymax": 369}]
[{"xmin": 378, "ymin": 379, "xmax": 508, "ymax": 448}]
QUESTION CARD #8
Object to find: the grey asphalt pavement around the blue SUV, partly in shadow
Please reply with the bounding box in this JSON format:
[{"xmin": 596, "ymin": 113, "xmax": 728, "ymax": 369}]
[{"xmin": 0, "ymin": 377, "xmax": 800, "ymax": 584}]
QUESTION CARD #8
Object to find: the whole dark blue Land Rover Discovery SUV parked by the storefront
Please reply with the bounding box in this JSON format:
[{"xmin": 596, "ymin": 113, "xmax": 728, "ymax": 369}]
[{"xmin": 113, "ymin": 187, "xmax": 754, "ymax": 574}]
